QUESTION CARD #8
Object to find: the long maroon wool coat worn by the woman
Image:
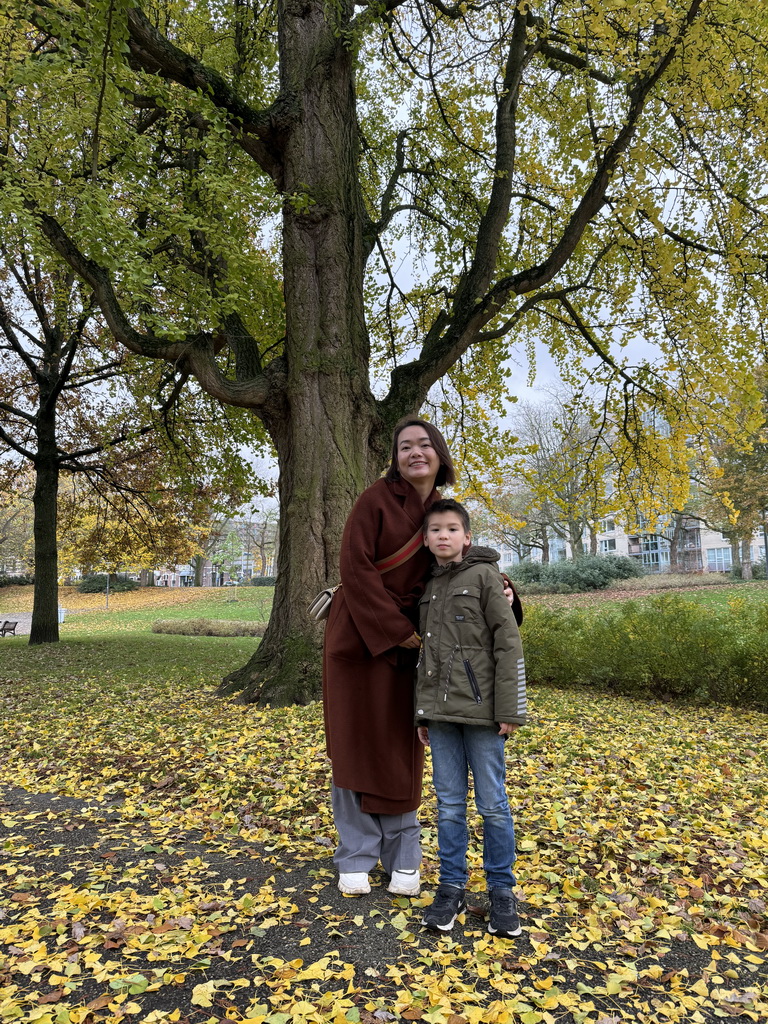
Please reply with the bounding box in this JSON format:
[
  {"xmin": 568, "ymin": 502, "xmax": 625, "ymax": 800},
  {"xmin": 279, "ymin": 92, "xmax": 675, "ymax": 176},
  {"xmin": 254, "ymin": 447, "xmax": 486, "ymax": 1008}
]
[{"xmin": 323, "ymin": 479, "xmax": 440, "ymax": 814}]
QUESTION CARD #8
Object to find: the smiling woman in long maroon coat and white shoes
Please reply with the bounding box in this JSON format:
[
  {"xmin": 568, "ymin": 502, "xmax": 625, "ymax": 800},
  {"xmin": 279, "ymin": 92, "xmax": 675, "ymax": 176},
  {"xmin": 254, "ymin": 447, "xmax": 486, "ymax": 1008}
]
[{"xmin": 323, "ymin": 417, "xmax": 456, "ymax": 896}]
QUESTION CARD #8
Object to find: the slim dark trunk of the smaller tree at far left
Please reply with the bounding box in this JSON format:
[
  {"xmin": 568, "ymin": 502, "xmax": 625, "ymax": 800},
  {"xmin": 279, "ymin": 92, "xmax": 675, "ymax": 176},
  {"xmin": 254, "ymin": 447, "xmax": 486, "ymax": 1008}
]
[{"xmin": 30, "ymin": 395, "xmax": 58, "ymax": 644}]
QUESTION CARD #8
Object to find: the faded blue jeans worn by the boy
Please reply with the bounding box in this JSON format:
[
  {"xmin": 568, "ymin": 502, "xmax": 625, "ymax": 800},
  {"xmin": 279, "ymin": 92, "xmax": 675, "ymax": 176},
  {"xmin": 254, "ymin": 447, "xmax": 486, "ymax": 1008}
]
[{"xmin": 429, "ymin": 722, "xmax": 515, "ymax": 889}]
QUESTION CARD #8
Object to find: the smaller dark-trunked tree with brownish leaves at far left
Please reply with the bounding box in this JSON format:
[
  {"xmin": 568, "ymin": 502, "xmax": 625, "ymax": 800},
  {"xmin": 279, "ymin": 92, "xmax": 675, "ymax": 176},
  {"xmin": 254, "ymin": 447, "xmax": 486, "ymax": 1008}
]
[{"xmin": 0, "ymin": 231, "xmax": 262, "ymax": 644}]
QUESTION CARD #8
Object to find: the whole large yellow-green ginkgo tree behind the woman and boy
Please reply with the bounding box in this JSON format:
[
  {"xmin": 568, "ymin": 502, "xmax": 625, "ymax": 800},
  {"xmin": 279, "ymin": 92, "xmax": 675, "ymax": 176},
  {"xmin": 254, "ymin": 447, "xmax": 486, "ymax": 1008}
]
[{"xmin": 0, "ymin": 0, "xmax": 768, "ymax": 698}]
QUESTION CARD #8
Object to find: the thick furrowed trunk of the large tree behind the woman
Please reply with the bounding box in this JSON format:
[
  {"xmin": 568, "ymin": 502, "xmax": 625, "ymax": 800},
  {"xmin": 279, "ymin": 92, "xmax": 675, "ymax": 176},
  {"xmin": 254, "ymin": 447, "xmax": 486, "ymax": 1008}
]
[{"xmin": 220, "ymin": 0, "xmax": 381, "ymax": 705}]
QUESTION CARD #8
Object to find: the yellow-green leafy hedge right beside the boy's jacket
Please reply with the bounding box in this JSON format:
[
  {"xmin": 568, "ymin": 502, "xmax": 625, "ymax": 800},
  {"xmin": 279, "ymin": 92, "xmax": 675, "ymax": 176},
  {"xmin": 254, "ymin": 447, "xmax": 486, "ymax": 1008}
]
[{"xmin": 521, "ymin": 594, "xmax": 768, "ymax": 710}]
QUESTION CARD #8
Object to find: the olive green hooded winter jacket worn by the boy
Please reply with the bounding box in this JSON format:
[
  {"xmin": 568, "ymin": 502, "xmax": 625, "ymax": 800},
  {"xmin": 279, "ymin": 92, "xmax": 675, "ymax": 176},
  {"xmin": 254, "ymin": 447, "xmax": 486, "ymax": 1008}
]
[{"xmin": 416, "ymin": 547, "xmax": 526, "ymax": 725}]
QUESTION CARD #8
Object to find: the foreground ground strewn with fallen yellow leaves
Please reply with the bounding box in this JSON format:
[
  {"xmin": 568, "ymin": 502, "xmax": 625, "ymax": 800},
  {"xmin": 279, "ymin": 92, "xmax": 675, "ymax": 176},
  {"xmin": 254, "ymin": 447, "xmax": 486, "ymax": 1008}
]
[{"xmin": 0, "ymin": 630, "xmax": 768, "ymax": 1024}]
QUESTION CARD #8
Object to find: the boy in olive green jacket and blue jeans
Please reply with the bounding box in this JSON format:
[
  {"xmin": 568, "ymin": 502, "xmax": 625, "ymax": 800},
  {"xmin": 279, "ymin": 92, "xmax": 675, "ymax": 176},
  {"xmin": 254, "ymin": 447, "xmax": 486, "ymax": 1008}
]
[{"xmin": 416, "ymin": 499, "xmax": 526, "ymax": 938}]
